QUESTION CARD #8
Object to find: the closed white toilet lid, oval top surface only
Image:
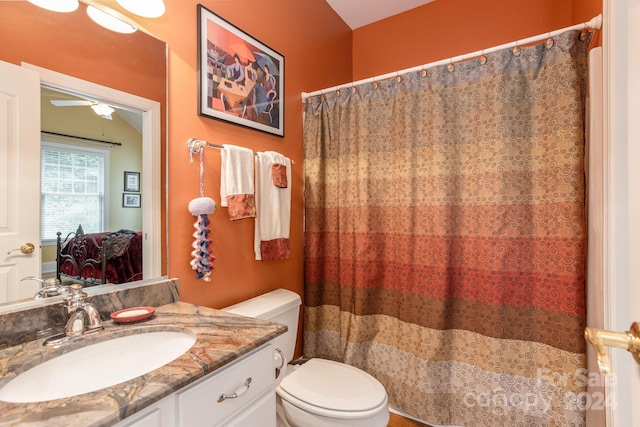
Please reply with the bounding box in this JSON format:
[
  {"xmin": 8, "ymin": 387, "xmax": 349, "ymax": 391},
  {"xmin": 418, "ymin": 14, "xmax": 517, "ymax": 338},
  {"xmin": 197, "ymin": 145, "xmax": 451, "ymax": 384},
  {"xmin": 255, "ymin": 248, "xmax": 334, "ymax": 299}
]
[{"xmin": 280, "ymin": 359, "xmax": 387, "ymax": 412}]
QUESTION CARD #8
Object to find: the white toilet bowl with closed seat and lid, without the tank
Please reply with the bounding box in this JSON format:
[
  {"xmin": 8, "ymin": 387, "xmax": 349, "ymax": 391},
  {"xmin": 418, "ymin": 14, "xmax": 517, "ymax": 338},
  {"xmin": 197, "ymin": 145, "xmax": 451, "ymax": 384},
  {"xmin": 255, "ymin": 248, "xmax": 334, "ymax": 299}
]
[{"xmin": 276, "ymin": 359, "xmax": 389, "ymax": 427}]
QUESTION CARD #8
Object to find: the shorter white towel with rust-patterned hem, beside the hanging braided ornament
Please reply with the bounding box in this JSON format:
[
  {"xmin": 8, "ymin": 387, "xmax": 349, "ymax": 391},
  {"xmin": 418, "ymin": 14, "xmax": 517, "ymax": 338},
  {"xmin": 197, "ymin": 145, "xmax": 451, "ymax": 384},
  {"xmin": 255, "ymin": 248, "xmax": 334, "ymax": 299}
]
[{"xmin": 220, "ymin": 144, "xmax": 256, "ymax": 220}]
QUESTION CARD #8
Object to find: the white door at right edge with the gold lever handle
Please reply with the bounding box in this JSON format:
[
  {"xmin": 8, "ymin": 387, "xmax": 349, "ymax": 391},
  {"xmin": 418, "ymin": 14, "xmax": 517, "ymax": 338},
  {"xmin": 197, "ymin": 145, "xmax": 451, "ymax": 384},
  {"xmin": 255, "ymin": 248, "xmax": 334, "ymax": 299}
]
[{"xmin": 602, "ymin": 0, "xmax": 640, "ymax": 427}]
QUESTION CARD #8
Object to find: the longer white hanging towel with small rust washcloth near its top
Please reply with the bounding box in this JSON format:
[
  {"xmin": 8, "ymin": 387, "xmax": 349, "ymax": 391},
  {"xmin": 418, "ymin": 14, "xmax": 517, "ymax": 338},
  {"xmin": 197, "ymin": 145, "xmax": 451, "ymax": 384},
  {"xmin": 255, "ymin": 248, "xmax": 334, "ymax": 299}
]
[{"xmin": 254, "ymin": 151, "xmax": 291, "ymax": 261}]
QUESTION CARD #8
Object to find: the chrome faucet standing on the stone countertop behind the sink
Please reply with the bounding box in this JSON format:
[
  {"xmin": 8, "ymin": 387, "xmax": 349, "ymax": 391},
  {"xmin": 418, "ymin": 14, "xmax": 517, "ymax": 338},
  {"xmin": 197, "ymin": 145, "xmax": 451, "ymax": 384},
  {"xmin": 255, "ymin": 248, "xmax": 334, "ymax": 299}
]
[{"xmin": 44, "ymin": 283, "xmax": 104, "ymax": 346}]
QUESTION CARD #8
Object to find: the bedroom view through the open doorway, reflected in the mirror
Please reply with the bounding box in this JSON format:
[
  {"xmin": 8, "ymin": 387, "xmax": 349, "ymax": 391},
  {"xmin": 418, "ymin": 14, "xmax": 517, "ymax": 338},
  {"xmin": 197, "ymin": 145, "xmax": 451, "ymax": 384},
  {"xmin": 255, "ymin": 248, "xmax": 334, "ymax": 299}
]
[{"xmin": 40, "ymin": 86, "xmax": 143, "ymax": 286}]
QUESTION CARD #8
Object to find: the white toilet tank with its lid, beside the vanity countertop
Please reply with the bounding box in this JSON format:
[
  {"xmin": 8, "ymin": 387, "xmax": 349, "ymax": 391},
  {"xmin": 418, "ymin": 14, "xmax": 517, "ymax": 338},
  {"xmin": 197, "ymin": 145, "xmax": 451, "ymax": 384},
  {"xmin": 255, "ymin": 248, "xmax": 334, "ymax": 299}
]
[{"xmin": 222, "ymin": 289, "xmax": 302, "ymax": 361}]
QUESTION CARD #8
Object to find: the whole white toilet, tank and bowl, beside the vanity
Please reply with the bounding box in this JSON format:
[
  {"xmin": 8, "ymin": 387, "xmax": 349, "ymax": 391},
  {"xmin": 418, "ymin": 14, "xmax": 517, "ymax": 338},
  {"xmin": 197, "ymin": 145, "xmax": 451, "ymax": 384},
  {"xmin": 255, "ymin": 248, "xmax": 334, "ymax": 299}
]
[{"xmin": 223, "ymin": 289, "xmax": 389, "ymax": 427}]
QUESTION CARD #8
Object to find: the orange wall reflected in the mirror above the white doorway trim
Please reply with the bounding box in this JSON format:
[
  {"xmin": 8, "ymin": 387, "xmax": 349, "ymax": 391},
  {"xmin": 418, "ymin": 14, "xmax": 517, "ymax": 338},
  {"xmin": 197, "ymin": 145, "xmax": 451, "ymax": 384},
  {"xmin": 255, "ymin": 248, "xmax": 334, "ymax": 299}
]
[{"xmin": 0, "ymin": 1, "xmax": 166, "ymax": 102}]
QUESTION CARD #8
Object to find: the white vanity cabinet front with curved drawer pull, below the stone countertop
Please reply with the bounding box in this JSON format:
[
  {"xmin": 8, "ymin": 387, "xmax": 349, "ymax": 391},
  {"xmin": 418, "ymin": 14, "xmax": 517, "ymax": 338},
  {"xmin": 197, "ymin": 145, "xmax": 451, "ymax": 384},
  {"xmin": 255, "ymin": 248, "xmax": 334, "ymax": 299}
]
[{"xmin": 116, "ymin": 344, "xmax": 276, "ymax": 427}]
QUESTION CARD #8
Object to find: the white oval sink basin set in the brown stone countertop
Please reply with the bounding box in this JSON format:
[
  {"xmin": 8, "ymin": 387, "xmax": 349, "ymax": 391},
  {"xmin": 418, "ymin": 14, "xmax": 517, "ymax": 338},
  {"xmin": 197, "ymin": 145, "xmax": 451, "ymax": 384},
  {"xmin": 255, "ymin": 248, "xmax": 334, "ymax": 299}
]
[{"xmin": 0, "ymin": 332, "xmax": 196, "ymax": 403}]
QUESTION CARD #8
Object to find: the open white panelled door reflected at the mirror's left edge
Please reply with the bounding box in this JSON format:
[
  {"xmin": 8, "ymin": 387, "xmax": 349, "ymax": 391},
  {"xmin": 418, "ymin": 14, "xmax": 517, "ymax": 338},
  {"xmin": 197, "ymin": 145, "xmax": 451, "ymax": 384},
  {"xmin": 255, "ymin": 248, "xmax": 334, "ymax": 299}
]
[{"xmin": 0, "ymin": 61, "xmax": 41, "ymax": 303}]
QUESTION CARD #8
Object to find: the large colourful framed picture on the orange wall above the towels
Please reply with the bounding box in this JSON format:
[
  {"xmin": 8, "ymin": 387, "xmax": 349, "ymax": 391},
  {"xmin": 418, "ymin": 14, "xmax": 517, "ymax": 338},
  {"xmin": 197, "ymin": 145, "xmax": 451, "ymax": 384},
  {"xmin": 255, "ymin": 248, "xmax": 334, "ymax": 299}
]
[{"xmin": 198, "ymin": 4, "xmax": 284, "ymax": 136}]
